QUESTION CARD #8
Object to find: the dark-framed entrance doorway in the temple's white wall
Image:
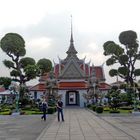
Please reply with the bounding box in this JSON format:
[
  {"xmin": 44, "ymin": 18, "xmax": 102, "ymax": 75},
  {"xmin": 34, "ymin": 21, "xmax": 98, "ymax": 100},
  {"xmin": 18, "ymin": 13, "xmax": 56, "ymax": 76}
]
[{"xmin": 66, "ymin": 91, "xmax": 80, "ymax": 105}]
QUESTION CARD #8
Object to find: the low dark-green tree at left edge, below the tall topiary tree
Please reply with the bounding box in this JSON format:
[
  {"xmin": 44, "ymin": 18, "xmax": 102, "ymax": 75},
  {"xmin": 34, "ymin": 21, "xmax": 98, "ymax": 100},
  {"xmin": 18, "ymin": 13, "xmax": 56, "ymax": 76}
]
[{"xmin": 0, "ymin": 77, "xmax": 11, "ymax": 89}]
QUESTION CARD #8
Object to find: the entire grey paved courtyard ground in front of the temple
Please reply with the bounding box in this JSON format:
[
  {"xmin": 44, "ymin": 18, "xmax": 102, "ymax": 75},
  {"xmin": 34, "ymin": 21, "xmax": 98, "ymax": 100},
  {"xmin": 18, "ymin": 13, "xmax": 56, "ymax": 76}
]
[{"xmin": 0, "ymin": 108, "xmax": 140, "ymax": 140}]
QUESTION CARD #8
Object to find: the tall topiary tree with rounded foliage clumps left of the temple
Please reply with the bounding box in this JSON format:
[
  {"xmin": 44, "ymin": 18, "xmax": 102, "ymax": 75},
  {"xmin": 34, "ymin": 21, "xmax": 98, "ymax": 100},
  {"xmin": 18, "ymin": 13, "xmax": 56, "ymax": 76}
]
[{"xmin": 0, "ymin": 33, "xmax": 52, "ymax": 100}]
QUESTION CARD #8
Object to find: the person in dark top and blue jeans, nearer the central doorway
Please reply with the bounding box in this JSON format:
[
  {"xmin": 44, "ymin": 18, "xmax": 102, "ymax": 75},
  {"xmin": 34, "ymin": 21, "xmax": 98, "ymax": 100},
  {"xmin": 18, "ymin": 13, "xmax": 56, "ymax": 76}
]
[{"xmin": 57, "ymin": 100, "xmax": 64, "ymax": 122}]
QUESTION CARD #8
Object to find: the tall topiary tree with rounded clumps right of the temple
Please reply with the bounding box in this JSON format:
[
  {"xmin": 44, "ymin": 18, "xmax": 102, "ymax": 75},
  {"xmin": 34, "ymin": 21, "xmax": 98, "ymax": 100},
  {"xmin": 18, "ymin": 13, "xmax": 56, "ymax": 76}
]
[{"xmin": 103, "ymin": 30, "xmax": 140, "ymax": 86}]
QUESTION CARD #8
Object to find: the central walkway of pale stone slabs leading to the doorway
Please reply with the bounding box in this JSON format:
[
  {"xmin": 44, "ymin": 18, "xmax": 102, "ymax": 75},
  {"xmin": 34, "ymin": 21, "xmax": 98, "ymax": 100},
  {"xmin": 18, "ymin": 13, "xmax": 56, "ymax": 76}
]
[{"xmin": 37, "ymin": 108, "xmax": 137, "ymax": 140}]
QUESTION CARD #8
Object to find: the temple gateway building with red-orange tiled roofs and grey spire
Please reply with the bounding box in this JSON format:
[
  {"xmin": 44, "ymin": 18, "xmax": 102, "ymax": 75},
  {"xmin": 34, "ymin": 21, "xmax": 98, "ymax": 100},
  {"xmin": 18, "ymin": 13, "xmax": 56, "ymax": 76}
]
[{"xmin": 30, "ymin": 27, "xmax": 110, "ymax": 107}]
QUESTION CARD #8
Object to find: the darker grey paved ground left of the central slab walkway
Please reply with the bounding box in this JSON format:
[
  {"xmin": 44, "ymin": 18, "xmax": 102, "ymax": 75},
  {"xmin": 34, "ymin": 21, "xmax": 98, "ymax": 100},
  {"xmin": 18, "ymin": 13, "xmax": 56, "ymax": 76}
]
[{"xmin": 0, "ymin": 115, "xmax": 54, "ymax": 140}]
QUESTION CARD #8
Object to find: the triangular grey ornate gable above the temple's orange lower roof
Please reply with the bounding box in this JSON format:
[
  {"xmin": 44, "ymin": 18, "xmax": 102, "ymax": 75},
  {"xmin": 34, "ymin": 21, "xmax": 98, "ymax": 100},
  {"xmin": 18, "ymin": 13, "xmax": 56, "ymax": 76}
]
[{"xmin": 59, "ymin": 59, "xmax": 85, "ymax": 79}]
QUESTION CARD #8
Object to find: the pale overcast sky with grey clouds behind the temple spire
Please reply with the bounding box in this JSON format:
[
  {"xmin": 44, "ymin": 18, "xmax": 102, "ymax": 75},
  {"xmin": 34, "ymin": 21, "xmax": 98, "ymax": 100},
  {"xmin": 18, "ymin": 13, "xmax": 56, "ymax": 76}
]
[{"xmin": 0, "ymin": 0, "xmax": 140, "ymax": 83}]
